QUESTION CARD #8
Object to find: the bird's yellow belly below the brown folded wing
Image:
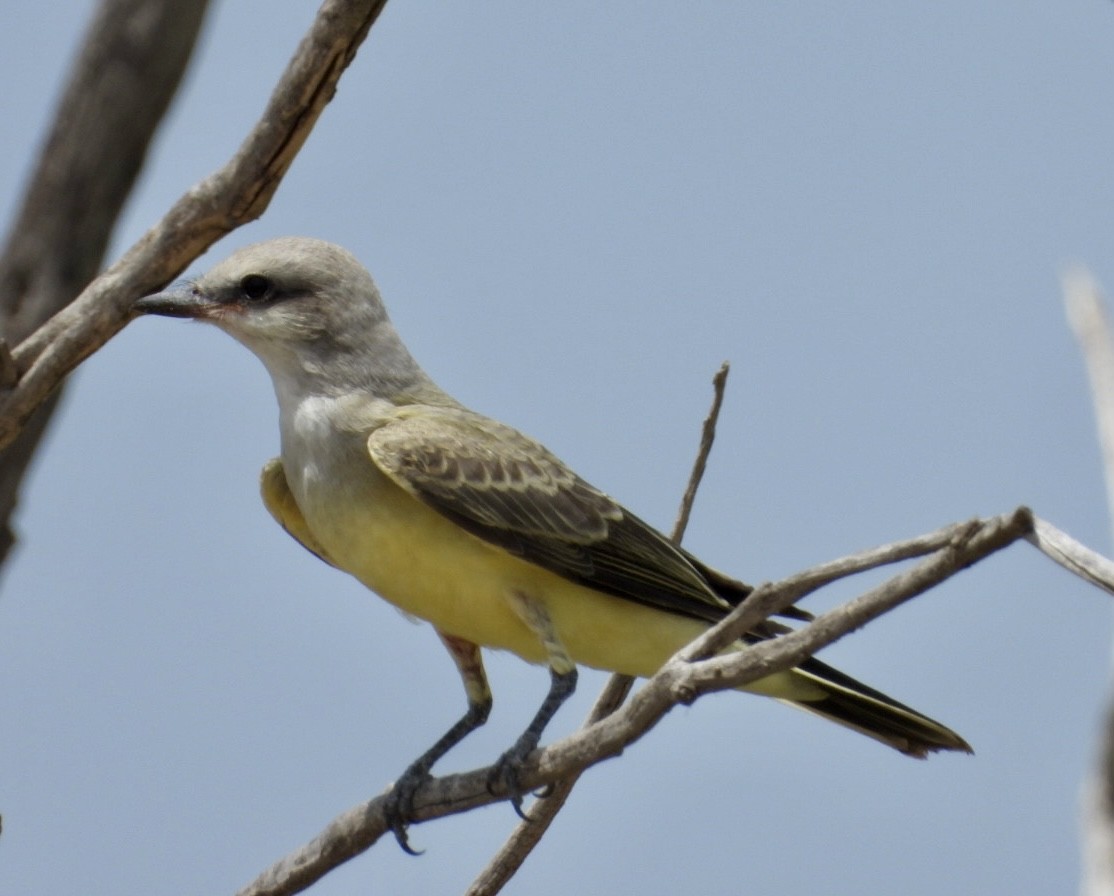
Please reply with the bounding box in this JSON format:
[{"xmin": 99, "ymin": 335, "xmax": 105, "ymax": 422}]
[{"xmin": 291, "ymin": 459, "xmax": 815, "ymax": 699}]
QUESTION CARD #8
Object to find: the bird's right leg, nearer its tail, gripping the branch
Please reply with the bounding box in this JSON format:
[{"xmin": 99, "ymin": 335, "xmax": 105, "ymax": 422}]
[{"xmin": 488, "ymin": 593, "xmax": 576, "ymax": 819}]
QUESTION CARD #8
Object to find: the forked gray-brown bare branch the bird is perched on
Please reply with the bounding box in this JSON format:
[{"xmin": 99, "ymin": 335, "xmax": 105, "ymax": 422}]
[{"xmin": 240, "ymin": 507, "xmax": 1060, "ymax": 896}]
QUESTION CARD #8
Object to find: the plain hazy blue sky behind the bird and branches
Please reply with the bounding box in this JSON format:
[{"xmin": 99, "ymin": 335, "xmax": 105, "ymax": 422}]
[{"xmin": 0, "ymin": 0, "xmax": 1114, "ymax": 896}]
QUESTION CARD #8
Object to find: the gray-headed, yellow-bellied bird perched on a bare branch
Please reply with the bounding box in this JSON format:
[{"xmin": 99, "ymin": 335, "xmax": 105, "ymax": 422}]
[{"xmin": 134, "ymin": 236, "xmax": 971, "ymax": 853}]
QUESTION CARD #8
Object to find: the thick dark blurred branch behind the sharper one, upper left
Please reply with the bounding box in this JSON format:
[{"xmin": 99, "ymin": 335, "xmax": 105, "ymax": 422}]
[{"xmin": 0, "ymin": 0, "xmax": 208, "ymax": 564}]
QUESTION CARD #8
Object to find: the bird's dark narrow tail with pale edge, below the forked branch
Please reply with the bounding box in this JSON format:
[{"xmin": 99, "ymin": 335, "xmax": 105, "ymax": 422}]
[{"xmin": 785, "ymin": 659, "xmax": 974, "ymax": 759}]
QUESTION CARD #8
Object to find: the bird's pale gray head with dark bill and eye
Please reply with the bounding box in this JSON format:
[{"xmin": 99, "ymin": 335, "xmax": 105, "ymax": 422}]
[{"xmin": 135, "ymin": 236, "xmax": 428, "ymax": 395}]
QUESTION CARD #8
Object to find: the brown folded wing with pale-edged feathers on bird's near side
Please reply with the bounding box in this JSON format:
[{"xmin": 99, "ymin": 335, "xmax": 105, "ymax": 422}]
[{"xmin": 368, "ymin": 406, "xmax": 750, "ymax": 621}]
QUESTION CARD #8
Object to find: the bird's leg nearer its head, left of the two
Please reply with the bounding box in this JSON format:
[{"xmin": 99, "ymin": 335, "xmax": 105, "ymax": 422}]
[{"xmin": 383, "ymin": 632, "xmax": 491, "ymax": 856}]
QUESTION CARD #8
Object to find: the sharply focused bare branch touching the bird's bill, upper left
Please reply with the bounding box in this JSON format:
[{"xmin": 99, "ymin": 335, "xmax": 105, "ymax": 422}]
[{"xmin": 0, "ymin": 0, "xmax": 385, "ymax": 448}]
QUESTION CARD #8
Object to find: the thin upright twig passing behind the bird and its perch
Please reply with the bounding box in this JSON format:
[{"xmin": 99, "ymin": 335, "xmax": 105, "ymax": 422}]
[{"xmin": 465, "ymin": 362, "xmax": 731, "ymax": 896}]
